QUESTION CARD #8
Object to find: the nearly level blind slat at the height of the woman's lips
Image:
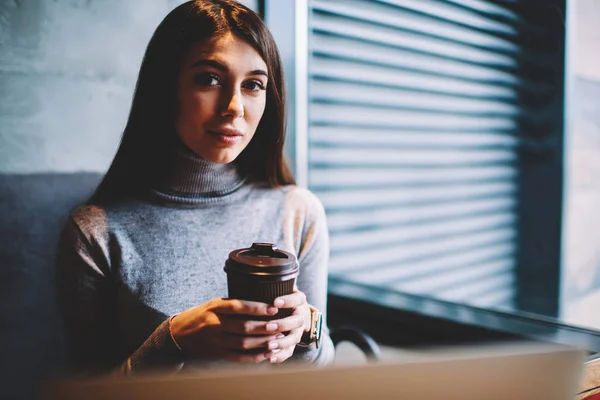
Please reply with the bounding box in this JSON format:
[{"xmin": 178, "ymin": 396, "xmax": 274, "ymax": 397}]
[{"xmin": 310, "ymin": 126, "xmax": 520, "ymax": 148}]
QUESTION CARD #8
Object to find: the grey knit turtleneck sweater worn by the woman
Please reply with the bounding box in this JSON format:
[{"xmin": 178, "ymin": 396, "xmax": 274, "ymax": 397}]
[{"xmin": 57, "ymin": 145, "xmax": 334, "ymax": 374}]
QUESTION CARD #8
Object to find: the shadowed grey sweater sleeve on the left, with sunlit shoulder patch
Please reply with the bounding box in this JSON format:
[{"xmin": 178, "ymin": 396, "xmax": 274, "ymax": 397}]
[{"xmin": 55, "ymin": 207, "xmax": 182, "ymax": 375}]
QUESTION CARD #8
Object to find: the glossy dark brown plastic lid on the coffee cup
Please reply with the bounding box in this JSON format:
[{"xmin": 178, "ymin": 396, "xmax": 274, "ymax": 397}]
[{"xmin": 223, "ymin": 243, "xmax": 298, "ymax": 279}]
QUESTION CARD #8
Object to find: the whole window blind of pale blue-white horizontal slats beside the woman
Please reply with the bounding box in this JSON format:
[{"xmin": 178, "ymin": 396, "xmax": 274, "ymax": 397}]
[{"xmin": 308, "ymin": 0, "xmax": 527, "ymax": 308}]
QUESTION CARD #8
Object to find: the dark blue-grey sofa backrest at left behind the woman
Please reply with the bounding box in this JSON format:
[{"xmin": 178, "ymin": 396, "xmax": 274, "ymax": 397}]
[{"xmin": 0, "ymin": 173, "xmax": 101, "ymax": 398}]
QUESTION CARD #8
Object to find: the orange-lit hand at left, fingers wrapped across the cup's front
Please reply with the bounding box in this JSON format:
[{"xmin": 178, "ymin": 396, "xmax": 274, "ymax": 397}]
[{"xmin": 171, "ymin": 299, "xmax": 302, "ymax": 363}]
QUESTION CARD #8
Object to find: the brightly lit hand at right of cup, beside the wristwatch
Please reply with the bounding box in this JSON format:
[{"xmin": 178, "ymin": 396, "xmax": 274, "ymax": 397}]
[{"xmin": 267, "ymin": 289, "xmax": 310, "ymax": 364}]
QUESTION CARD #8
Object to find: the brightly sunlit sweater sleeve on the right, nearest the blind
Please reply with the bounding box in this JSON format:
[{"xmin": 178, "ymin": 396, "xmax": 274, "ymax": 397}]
[{"xmin": 284, "ymin": 188, "xmax": 335, "ymax": 366}]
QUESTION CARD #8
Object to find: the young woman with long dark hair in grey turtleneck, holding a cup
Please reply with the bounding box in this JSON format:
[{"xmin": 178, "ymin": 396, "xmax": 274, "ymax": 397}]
[{"xmin": 57, "ymin": 0, "xmax": 334, "ymax": 374}]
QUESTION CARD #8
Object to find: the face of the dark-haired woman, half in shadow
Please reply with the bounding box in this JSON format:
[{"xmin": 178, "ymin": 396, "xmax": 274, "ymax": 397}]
[{"xmin": 176, "ymin": 34, "xmax": 268, "ymax": 163}]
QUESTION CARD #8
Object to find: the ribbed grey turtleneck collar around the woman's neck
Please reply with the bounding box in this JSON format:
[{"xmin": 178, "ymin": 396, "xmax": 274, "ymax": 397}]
[{"xmin": 153, "ymin": 139, "xmax": 245, "ymax": 204}]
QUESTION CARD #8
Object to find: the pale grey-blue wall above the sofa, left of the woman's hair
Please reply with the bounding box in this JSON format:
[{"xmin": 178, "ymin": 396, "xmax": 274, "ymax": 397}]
[{"xmin": 0, "ymin": 0, "xmax": 191, "ymax": 174}]
